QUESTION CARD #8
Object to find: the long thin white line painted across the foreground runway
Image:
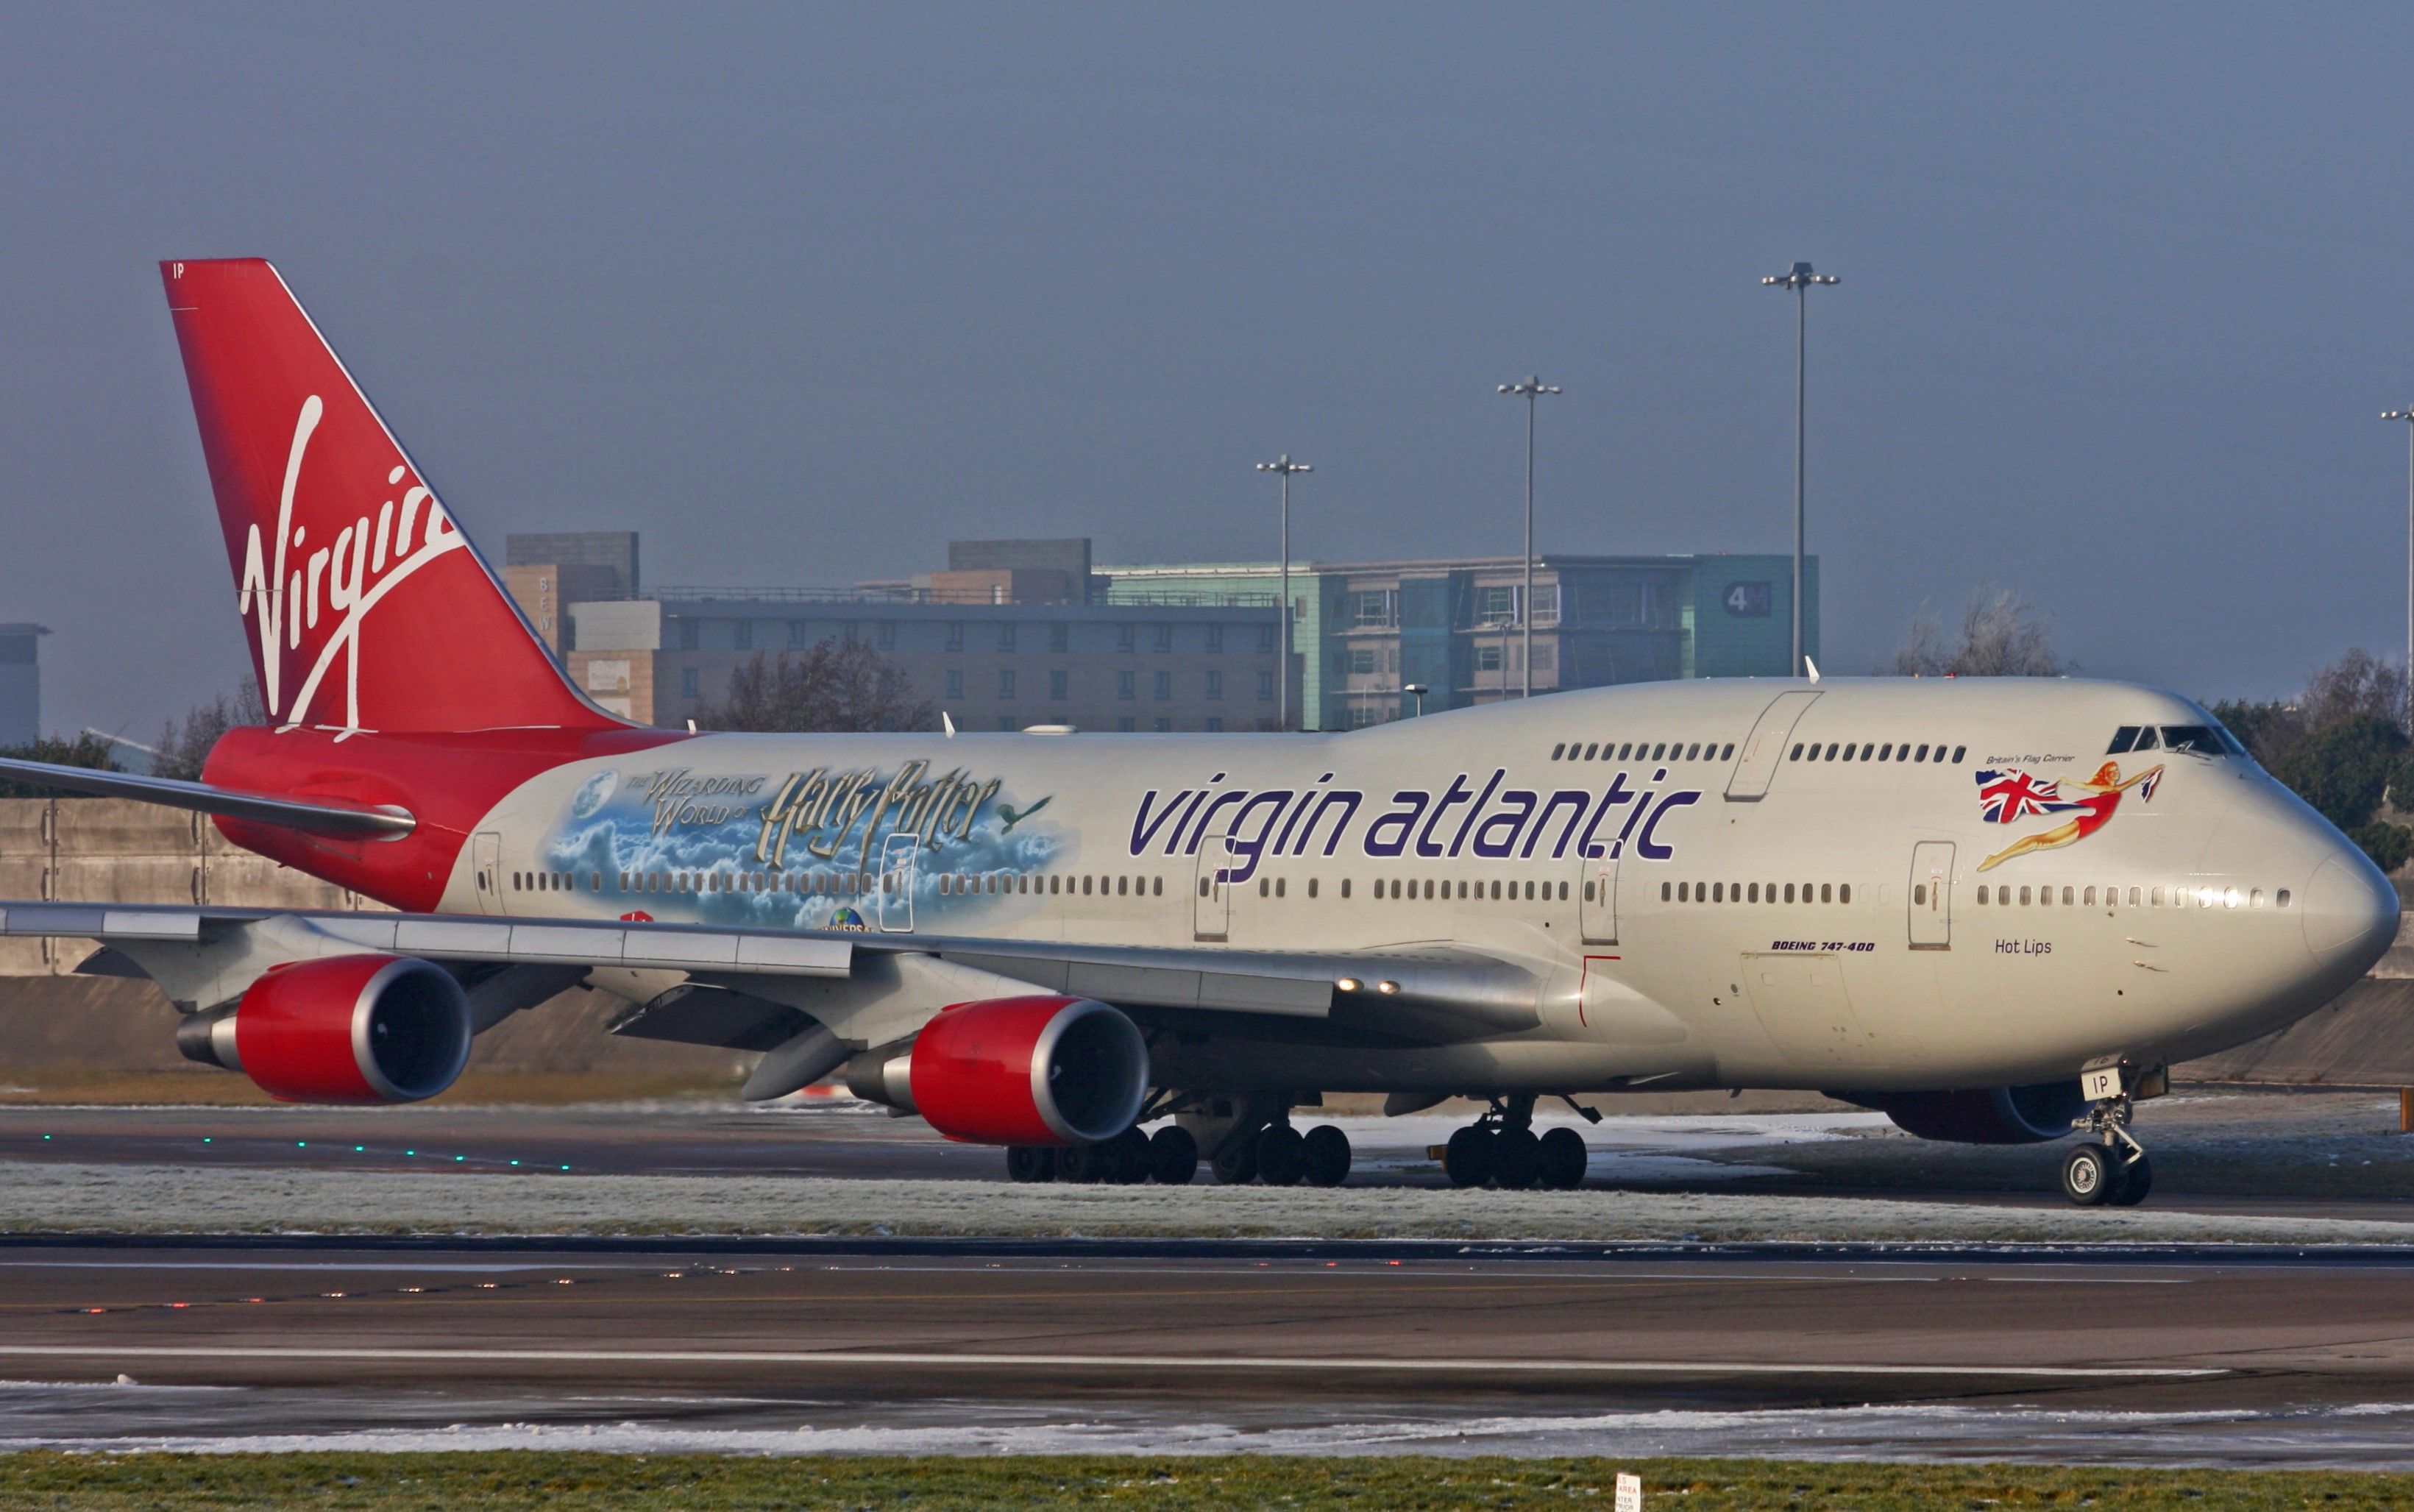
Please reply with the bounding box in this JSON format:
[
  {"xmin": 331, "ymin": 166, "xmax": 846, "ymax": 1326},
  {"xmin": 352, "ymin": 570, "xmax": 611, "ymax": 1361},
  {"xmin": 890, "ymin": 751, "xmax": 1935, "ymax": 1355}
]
[{"xmin": 0, "ymin": 1343, "xmax": 2231, "ymax": 1382}]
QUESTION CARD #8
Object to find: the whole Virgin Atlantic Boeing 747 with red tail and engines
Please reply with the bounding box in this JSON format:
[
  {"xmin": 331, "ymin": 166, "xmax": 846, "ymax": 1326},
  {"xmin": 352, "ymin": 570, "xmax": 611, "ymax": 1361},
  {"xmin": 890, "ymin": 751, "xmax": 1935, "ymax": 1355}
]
[{"xmin": 0, "ymin": 258, "xmax": 2399, "ymax": 1205}]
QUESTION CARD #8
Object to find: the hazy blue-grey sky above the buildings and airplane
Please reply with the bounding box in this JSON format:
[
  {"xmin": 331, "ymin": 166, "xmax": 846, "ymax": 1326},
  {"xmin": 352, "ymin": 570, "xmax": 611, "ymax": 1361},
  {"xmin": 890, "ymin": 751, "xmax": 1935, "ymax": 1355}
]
[{"xmin": 0, "ymin": 2, "xmax": 2414, "ymax": 737}]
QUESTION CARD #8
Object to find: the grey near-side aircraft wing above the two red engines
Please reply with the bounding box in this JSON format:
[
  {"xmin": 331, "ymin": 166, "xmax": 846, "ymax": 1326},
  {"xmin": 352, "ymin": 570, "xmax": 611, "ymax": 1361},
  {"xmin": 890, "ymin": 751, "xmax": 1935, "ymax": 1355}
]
[{"xmin": 0, "ymin": 904, "xmax": 1540, "ymax": 1051}]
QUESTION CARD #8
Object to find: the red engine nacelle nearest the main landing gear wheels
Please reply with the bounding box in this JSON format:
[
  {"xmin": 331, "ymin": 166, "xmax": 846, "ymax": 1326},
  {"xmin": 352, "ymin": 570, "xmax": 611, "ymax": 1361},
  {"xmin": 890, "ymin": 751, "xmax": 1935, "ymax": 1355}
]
[{"xmin": 848, "ymin": 998, "xmax": 1149, "ymax": 1145}]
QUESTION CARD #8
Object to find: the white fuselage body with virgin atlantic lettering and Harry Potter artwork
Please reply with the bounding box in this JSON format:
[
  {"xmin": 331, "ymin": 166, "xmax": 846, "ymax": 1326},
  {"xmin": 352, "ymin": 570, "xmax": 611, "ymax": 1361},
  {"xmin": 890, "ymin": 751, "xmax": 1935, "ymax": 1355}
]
[{"xmin": 444, "ymin": 678, "xmax": 2397, "ymax": 1092}]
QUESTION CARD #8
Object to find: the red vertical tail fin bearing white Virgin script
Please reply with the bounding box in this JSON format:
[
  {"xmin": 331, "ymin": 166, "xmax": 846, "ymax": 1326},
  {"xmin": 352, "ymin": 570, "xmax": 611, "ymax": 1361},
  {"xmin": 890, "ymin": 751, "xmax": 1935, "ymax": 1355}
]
[{"xmin": 160, "ymin": 258, "xmax": 618, "ymax": 732}]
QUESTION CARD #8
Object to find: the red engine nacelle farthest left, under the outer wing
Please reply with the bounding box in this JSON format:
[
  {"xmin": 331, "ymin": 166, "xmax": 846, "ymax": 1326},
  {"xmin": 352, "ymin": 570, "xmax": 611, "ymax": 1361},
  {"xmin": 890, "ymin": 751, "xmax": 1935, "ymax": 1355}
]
[{"xmin": 177, "ymin": 954, "xmax": 471, "ymax": 1101}]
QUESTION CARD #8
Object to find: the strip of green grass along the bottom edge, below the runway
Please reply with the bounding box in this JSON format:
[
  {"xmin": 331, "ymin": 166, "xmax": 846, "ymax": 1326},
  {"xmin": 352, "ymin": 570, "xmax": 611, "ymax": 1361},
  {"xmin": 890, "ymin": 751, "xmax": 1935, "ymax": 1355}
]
[{"xmin": 0, "ymin": 1452, "xmax": 2414, "ymax": 1512}]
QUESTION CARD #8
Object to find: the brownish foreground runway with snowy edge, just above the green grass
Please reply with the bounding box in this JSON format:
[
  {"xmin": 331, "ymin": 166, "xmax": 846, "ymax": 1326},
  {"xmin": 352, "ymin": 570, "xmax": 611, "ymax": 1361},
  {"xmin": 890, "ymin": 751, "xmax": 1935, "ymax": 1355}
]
[{"xmin": 0, "ymin": 1239, "xmax": 2414, "ymax": 1466}]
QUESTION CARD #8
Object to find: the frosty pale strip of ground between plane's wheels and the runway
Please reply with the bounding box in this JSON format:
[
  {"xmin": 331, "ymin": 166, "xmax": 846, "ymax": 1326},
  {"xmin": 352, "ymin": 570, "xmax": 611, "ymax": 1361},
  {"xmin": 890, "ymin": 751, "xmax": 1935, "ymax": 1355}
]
[{"xmin": 14, "ymin": 1162, "xmax": 2414, "ymax": 1244}]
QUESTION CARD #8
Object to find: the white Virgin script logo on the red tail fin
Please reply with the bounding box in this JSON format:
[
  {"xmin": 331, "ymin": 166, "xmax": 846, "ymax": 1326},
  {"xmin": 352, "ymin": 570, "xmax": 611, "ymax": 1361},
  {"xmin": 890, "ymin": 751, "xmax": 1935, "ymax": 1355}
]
[{"xmin": 234, "ymin": 394, "xmax": 466, "ymax": 732}]
